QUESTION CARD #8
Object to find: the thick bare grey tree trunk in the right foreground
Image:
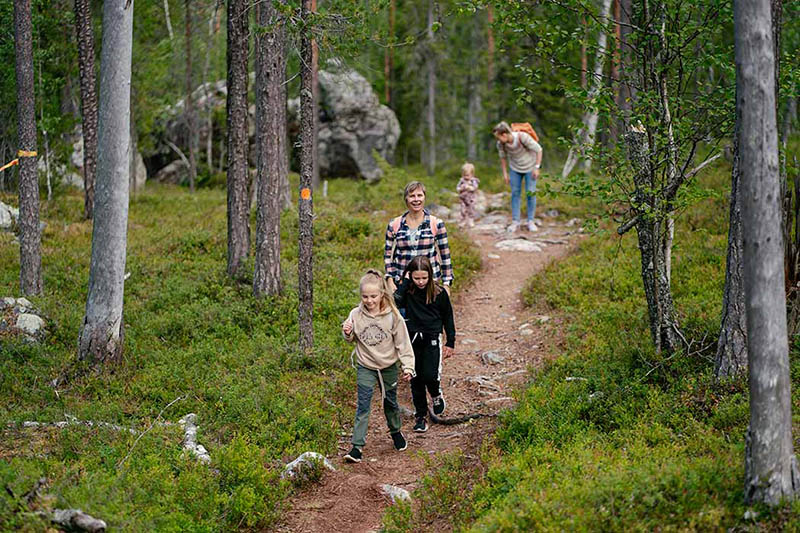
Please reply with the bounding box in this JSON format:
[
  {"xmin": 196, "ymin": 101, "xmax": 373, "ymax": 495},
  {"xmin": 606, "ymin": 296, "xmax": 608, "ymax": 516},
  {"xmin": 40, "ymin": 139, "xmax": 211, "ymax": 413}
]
[{"xmin": 734, "ymin": 0, "xmax": 800, "ymax": 506}]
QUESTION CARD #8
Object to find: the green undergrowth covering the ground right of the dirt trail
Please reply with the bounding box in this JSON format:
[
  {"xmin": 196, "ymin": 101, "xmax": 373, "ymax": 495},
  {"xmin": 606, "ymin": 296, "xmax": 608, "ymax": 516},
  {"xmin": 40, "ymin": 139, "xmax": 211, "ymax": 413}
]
[{"xmin": 385, "ymin": 157, "xmax": 800, "ymax": 532}]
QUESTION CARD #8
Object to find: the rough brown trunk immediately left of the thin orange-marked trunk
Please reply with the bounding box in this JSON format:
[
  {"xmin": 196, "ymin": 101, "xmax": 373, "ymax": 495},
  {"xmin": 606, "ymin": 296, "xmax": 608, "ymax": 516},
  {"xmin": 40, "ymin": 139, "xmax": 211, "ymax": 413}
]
[{"xmin": 253, "ymin": 2, "xmax": 286, "ymax": 297}]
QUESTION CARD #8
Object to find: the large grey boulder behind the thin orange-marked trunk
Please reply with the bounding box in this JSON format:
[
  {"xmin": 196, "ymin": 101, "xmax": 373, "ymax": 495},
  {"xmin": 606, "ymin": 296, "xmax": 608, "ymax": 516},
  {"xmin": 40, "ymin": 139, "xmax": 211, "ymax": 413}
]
[{"xmin": 289, "ymin": 60, "xmax": 400, "ymax": 181}]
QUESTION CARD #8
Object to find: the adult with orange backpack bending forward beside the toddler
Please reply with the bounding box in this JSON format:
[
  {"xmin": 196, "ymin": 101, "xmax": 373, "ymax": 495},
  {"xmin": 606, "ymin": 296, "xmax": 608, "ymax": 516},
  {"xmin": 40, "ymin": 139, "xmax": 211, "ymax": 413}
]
[{"xmin": 492, "ymin": 122, "xmax": 542, "ymax": 233}]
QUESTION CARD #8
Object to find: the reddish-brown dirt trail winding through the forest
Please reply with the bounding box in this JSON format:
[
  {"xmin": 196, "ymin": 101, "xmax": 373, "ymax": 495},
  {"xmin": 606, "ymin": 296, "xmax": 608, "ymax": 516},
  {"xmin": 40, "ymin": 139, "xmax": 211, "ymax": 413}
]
[{"xmin": 276, "ymin": 215, "xmax": 578, "ymax": 533}]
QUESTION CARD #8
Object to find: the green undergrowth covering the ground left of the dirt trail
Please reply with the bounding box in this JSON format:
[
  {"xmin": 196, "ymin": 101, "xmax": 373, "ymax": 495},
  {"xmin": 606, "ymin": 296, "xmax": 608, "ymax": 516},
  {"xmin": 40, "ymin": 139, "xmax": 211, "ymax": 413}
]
[{"xmin": 0, "ymin": 167, "xmax": 480, "ymax": 531}]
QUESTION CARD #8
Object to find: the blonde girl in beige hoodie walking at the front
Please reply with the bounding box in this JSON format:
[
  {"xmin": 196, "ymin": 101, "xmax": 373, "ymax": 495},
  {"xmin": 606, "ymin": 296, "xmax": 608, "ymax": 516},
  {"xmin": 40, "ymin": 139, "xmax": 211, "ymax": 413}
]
[{"xmin": 342, "ymin": 270, "xmax": 414, "ymax": 463}]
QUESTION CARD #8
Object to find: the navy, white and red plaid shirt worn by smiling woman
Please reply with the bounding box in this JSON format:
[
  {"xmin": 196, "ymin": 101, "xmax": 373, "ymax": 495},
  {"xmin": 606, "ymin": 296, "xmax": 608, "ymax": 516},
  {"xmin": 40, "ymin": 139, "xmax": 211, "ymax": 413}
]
[{"xmin": 383, "ymin": 210, "xmax": 453, "ymax": 286}]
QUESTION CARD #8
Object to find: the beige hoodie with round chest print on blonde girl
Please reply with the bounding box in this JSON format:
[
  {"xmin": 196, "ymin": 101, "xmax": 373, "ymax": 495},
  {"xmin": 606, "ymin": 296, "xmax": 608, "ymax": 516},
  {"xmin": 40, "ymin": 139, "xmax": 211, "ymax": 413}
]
[{"xmin": 342, "ymin": 305, "xmax": 414, "ymax": 375}]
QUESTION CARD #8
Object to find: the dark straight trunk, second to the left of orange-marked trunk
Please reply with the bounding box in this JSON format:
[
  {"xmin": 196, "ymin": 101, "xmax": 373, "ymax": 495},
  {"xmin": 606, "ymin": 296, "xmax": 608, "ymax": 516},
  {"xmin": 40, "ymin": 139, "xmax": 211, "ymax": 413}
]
[{"xmin": 227, "ymin": 0, "xmax": 250, "ymax": 277}]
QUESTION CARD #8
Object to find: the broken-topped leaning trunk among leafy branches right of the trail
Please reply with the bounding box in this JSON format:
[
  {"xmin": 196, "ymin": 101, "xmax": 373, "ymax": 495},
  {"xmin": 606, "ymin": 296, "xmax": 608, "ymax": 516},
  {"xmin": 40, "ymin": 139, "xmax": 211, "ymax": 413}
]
[{"xmin": 625, "ymin": 129, "xmax": 681, "ymax": 353}]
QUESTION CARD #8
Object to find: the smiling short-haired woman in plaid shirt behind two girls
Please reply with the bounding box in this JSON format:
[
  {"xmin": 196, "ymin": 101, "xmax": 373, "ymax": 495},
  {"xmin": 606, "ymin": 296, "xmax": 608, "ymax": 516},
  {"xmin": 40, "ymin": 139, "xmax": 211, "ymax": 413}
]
[{"xmin": 383, "ymin": 181, "xmax": 453, "ymax": 294}]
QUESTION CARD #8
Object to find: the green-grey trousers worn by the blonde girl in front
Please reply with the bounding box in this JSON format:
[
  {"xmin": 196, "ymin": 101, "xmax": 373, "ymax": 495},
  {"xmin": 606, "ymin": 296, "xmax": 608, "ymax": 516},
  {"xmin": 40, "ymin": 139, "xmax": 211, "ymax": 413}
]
[{"xmin": 352, "ymin": 363, "xmax": 401, "ymax": 448}]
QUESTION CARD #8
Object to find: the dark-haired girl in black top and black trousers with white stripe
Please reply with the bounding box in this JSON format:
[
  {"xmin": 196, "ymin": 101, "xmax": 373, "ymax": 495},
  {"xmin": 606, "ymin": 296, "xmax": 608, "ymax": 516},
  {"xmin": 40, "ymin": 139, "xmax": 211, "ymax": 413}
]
[{"xmin": 394, "ymin": 256, "xmax": 456, "ymax": 433}]
